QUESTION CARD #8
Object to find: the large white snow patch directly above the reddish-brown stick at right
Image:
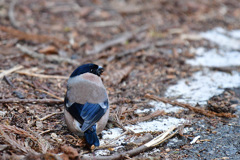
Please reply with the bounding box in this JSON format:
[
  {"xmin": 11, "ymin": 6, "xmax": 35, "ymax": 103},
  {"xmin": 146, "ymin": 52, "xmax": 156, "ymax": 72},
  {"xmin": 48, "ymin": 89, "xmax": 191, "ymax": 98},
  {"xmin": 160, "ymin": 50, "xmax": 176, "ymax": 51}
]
[{"xmin": 165, "ymin": 69, "xmax": 240, "ymax": 105}]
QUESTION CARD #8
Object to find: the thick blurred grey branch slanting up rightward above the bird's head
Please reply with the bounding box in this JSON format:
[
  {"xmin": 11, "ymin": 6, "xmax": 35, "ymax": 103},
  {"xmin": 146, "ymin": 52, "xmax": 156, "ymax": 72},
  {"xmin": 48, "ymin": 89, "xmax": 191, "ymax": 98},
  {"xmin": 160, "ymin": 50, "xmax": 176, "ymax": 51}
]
[{"xmin": 87, "ymin": 26, "xmax": 148, "ymax": 54}]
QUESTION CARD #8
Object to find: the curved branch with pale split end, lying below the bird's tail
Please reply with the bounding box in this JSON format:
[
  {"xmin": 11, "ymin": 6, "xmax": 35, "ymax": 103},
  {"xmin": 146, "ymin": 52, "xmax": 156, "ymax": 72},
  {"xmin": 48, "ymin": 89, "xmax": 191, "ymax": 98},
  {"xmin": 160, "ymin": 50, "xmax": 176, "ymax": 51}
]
[{"xmin": 80, "ymin": 126, "xmax": 178, "ymax": 160}]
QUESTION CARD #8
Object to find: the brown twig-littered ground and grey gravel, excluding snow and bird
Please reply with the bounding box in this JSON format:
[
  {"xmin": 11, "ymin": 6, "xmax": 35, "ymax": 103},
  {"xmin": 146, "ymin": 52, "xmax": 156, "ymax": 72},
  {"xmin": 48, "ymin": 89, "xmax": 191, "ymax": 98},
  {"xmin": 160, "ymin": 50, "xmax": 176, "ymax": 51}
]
[{"xmin": 0, "ymin": 0, "xmax": 240, "ymax": 160}]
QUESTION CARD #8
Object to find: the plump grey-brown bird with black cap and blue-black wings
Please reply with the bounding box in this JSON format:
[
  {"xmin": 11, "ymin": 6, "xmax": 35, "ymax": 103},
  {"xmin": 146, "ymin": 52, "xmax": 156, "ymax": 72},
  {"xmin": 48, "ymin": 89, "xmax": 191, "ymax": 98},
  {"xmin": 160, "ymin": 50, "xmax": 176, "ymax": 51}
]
[{"xmin": 64, "ymin": 63, "xmax": 109, "ymax": 147}]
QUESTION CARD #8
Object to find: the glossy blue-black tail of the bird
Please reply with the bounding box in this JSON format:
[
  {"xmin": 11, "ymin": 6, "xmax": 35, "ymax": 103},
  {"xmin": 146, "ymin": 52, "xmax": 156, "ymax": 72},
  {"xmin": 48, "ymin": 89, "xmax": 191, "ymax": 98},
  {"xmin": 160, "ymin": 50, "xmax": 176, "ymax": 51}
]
[{"xmin": 84, "ymin": 125, "xmax": 99, "ymax": 147}]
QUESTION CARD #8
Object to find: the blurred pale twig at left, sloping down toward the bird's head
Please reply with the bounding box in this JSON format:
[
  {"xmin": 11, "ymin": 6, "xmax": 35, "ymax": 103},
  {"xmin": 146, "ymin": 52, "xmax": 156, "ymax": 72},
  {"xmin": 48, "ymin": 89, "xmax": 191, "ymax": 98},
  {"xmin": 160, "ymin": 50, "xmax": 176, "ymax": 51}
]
[{"xmin": 16, "ymin": 44, "xmax": 79, "ymax": 65}]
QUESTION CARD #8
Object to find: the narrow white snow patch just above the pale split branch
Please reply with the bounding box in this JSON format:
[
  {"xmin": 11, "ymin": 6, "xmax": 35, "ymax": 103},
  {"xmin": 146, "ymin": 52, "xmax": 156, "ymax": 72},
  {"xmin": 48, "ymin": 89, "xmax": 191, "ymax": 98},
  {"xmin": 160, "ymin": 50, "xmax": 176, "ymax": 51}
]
[{"xmin": 126, "ymin": 117, "xmax": 186, "ymax": 133}]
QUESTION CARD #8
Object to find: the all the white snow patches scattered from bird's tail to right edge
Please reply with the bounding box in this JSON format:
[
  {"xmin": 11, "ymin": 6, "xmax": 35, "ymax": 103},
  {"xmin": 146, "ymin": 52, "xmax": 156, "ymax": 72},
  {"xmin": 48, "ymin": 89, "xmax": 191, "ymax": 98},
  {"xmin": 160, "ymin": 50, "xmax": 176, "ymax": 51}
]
[{"xmin": 91, "ymin": 28, "xmax": 240, "ymax": 155}]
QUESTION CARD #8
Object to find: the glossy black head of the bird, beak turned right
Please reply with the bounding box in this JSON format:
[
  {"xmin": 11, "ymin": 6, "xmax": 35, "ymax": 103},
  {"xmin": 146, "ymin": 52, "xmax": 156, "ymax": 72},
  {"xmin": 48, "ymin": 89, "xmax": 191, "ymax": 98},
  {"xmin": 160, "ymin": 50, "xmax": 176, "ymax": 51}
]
[{"xmin": 70, "ymin": 63, "xmax": 103, "ymax": 77}]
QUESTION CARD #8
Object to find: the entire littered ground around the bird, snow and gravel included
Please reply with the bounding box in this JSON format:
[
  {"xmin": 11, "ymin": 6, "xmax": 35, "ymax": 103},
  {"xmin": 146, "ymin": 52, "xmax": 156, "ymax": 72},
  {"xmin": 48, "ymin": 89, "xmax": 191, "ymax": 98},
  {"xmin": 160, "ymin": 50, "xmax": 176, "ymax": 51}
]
[{"xmin": 0, "ymin": 0, "xmax": 240, "ymax": 160}]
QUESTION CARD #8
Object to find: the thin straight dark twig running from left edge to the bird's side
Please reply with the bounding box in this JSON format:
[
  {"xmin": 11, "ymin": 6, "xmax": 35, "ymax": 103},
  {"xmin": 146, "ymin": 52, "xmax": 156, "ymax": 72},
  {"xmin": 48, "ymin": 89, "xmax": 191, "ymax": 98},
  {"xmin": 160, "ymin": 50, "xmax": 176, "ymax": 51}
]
[{"xmin": 0, "ymin": 98, "xmax": 63, "ymax": 104}]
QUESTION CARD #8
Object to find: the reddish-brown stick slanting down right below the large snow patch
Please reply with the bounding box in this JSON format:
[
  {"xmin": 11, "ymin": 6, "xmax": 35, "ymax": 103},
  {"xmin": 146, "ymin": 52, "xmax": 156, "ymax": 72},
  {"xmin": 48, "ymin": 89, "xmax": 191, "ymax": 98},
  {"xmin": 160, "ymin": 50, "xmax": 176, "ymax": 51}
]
[{"xmin": 145, "ymin": 94, "xmax": 236, "ymax": 118}]
